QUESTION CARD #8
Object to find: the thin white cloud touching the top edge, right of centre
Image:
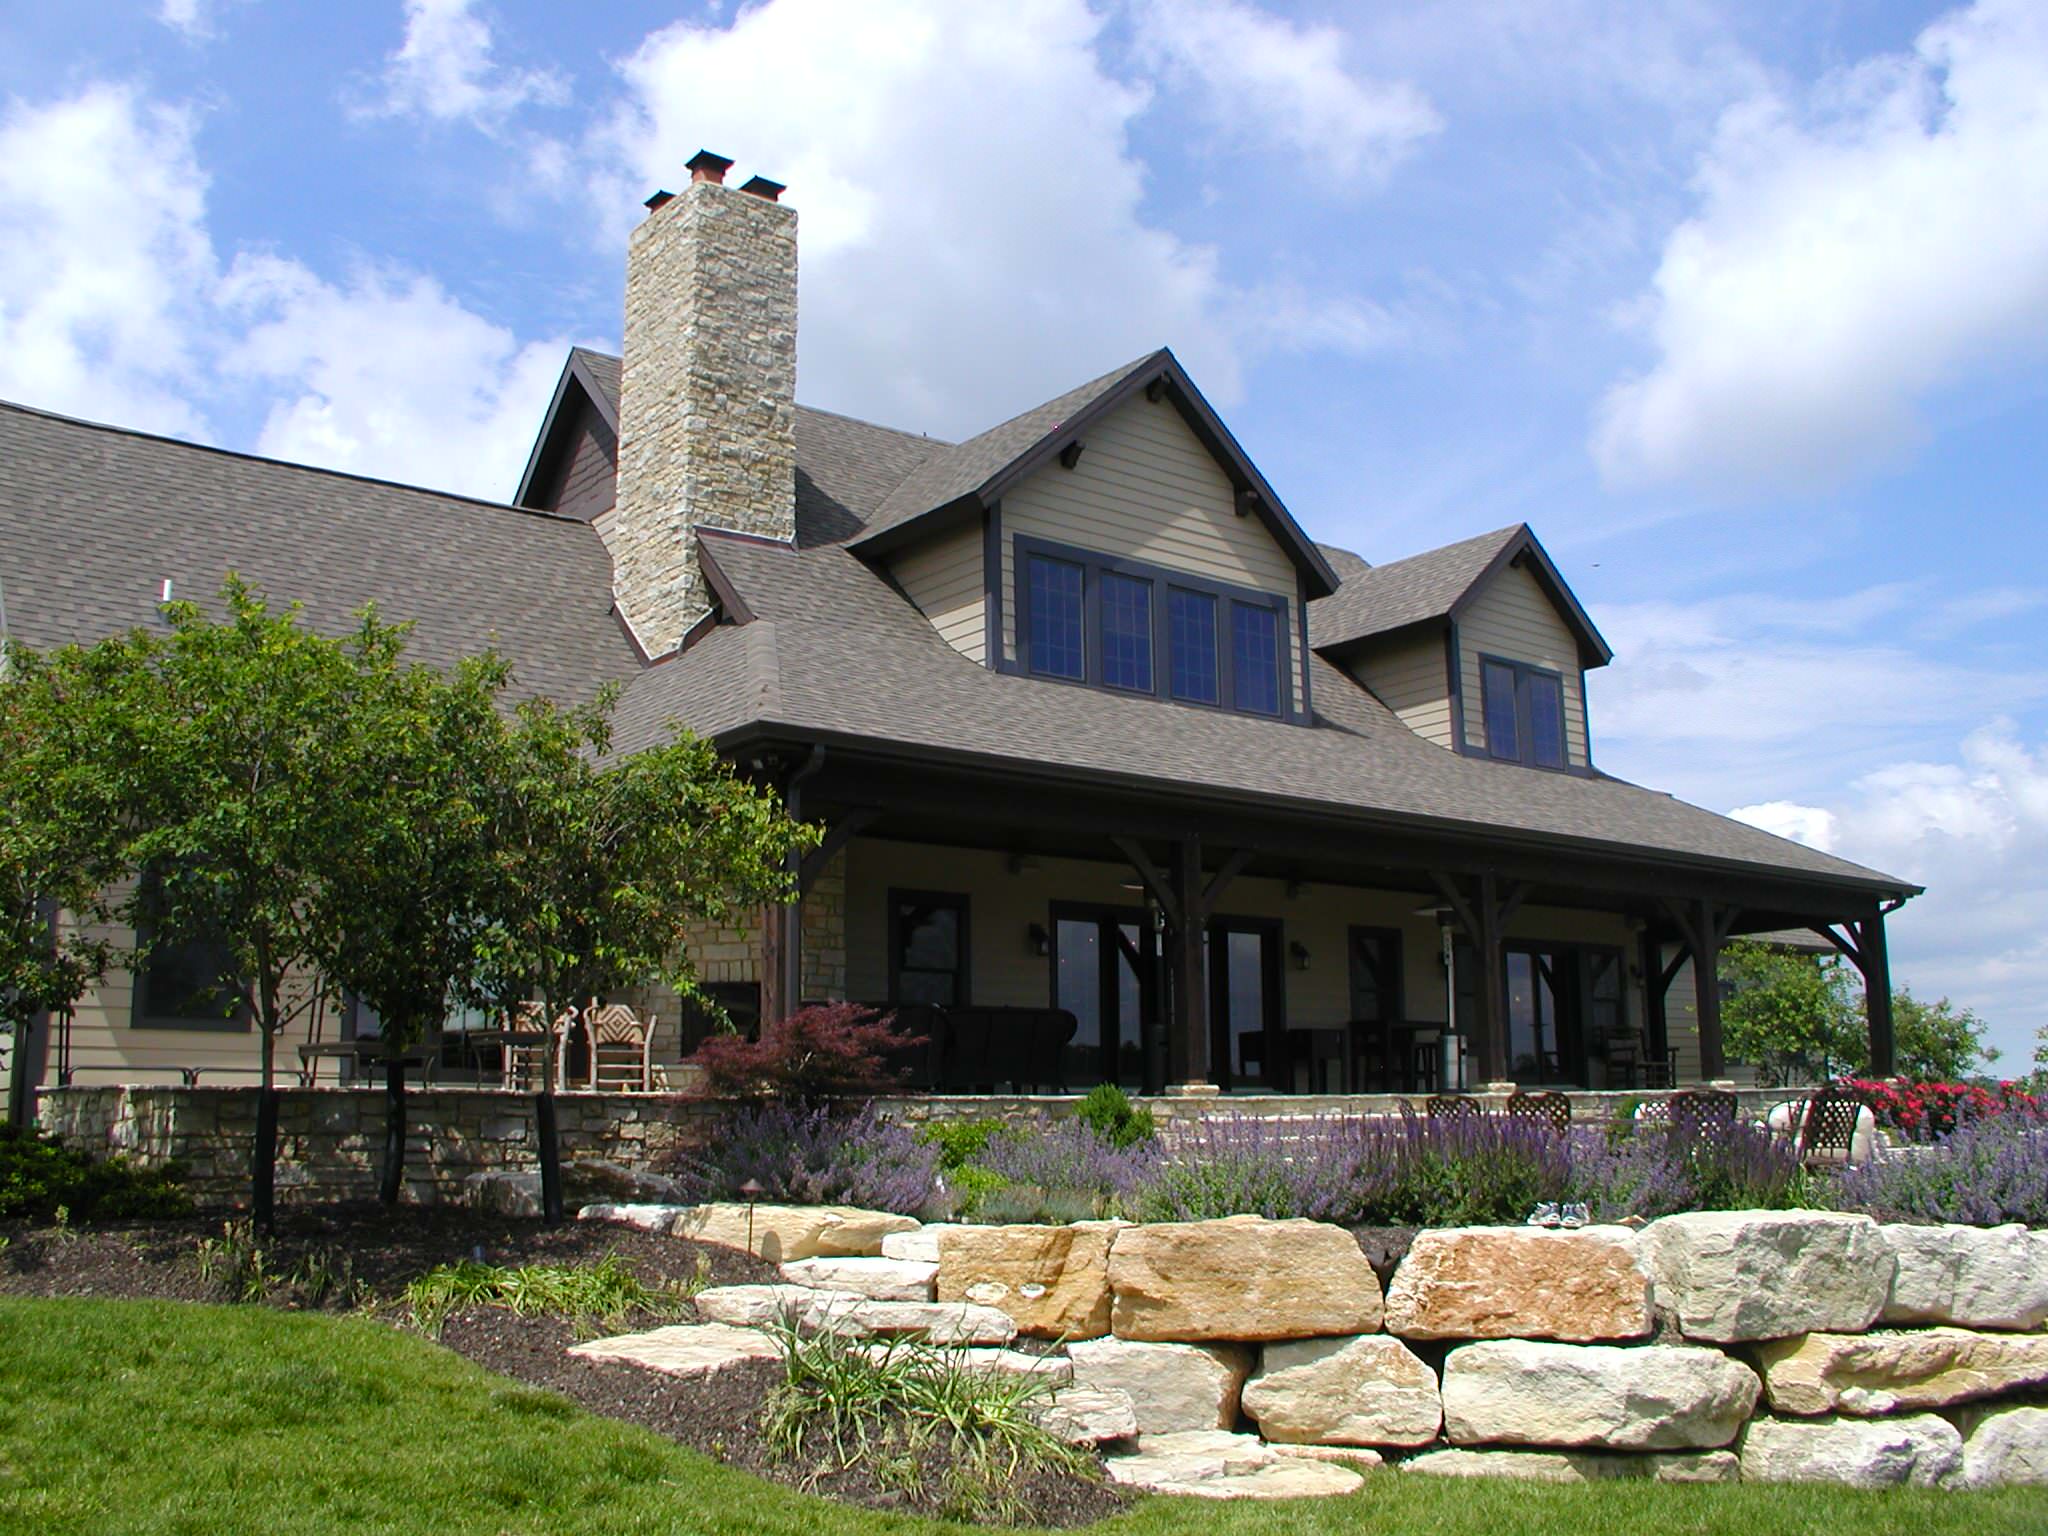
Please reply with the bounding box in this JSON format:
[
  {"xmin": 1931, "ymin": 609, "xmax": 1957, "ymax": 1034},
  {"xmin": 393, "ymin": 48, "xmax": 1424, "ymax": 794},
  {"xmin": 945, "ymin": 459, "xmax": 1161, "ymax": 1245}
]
[{"xmin": 1133, "ymin": 0, "xmax": 1444, "ymax": 182}]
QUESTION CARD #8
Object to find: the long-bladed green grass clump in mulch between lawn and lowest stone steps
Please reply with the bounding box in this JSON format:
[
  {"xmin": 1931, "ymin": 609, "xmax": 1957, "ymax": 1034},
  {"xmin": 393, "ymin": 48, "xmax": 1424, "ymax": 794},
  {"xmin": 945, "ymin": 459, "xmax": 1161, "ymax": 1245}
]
[{"xmin": 762, "ymin": 1319, "xmax": 1098, "ymax": 1526}]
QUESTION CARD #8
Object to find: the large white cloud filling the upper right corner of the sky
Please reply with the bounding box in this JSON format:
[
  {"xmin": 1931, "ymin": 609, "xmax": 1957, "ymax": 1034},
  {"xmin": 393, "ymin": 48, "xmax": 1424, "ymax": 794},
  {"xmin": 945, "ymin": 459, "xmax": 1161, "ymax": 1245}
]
[{"xmin": 1593, "ymin": 0, "xmax": 2048, "ymax": 489}]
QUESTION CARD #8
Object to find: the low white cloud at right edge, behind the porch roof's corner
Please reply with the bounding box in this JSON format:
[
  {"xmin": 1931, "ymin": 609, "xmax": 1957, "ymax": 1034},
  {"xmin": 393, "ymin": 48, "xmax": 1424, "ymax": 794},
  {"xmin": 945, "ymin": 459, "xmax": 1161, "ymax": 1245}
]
[{"xmin": 1733, "ymin": 721, "xmax": 2048, "ymax": 1071}]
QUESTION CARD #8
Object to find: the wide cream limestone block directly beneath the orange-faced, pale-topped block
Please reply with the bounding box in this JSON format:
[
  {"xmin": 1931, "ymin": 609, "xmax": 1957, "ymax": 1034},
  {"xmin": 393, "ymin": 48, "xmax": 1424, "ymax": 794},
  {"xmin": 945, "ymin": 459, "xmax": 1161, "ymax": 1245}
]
[{"xmin": 1444, "ymin": 1339, "xmax": 1759, "ymax": 1450}]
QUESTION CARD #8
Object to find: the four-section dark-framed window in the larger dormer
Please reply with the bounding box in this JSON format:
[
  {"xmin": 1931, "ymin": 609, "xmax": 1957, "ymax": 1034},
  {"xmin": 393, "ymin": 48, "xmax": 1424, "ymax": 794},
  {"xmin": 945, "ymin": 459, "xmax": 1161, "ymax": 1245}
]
[{"xmin": 1016, "ymin": 539, "xmax": 1294, "ymax": 719}]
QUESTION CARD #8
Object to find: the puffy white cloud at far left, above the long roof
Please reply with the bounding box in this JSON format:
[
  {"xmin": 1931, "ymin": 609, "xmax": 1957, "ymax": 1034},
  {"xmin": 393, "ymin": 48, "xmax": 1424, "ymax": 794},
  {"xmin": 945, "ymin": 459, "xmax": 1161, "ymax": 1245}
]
[{"xmin": 0, "ymin": 84, "xmax": 567, "ymax": 498}]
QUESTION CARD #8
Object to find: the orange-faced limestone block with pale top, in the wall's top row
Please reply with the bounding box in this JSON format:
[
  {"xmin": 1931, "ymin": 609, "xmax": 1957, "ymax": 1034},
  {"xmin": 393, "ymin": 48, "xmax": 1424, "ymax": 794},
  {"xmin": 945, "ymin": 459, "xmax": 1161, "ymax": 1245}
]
[{"xmin": 1384, "ymin": 1227, "xmax": 1651, "ymax": 1343}]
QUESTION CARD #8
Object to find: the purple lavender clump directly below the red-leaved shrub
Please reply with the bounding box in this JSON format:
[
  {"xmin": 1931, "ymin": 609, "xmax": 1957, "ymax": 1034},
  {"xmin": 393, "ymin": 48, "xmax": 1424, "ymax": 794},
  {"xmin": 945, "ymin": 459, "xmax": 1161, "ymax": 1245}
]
[{"xmin": 666, "ymin": 1104, "xmax": 940, "ymax": 1217}]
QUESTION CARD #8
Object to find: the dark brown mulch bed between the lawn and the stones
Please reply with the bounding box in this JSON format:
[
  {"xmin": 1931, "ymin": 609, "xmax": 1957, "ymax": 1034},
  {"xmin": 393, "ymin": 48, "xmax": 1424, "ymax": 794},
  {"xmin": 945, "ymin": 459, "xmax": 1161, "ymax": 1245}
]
[{"xmin": 0, "ymin": 1206, "xmax": 1128, "ymax": 1526}]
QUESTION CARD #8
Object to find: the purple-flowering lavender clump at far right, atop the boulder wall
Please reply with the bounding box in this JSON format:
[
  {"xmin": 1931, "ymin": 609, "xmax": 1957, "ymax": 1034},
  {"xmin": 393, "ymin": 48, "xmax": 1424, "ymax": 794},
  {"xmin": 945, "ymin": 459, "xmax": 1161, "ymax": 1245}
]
[{"xmin": 1829, "ymin": 1114, "xmax": 2048, "ymax": 1227}]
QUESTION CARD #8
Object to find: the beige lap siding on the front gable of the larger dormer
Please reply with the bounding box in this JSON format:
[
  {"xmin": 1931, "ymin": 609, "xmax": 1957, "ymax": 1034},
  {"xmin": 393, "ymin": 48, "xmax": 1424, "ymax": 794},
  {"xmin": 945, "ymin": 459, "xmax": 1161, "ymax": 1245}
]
[{"xmin": 1004, "ymin": 399, "xmax": 1303, "ymax": 707}]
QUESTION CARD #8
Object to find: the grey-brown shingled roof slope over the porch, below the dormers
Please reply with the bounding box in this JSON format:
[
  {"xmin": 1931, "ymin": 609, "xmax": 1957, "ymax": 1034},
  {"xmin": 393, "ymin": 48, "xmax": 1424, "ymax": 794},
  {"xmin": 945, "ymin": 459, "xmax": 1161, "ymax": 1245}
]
[{"xmin": 614, "ymin": 532, "xmax": 1919, "ymax": 897}]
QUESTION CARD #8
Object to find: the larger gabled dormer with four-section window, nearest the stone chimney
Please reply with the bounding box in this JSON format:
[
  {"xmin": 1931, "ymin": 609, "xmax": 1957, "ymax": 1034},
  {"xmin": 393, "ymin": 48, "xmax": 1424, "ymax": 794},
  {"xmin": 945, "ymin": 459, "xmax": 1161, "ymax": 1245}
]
[{"xmin": 854, "ymin": 350, "xmax": 1335, "ymax": 723}]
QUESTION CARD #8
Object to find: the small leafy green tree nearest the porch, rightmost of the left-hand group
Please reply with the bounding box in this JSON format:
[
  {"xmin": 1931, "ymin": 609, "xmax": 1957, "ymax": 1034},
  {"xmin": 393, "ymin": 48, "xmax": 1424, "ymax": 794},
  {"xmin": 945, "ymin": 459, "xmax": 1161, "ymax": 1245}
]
[{"xmin": 479, "ymin": 690, "xmax": 819, "ymax": 1221}]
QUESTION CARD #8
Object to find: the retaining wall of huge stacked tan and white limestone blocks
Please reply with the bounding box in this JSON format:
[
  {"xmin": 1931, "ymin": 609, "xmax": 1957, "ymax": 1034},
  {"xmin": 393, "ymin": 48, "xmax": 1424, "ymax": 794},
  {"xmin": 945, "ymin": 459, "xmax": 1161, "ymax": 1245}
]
[{"xmin": 622, "ymin": 1204, "xmax": 2048, "ymax": 1497}]
